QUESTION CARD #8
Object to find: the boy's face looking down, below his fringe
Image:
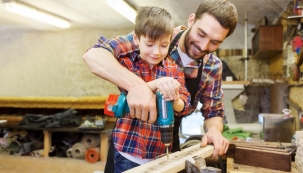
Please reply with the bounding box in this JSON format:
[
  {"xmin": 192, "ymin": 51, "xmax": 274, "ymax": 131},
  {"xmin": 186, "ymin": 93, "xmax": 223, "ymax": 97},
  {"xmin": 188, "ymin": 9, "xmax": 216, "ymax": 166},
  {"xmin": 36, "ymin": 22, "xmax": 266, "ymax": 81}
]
[{"xmin": 137, "ymin": 35, "xmax": 171, "ymax": 68}]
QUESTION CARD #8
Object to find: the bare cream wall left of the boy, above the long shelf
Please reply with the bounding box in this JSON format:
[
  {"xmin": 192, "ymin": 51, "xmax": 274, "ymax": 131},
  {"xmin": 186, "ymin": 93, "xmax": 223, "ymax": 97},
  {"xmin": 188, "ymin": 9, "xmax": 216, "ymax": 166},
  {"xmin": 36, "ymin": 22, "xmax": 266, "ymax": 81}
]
[{"xmin": 0, "ymin": 29, "xmax": 131, "ymax": 97}]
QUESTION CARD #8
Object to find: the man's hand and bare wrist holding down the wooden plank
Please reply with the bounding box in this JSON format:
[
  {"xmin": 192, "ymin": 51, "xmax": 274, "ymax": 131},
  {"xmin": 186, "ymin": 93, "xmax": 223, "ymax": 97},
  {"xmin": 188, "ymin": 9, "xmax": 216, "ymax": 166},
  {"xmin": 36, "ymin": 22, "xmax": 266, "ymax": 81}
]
[{"xmin": 201, "ymin": 117, "xmax": 229, "ymax": 157}]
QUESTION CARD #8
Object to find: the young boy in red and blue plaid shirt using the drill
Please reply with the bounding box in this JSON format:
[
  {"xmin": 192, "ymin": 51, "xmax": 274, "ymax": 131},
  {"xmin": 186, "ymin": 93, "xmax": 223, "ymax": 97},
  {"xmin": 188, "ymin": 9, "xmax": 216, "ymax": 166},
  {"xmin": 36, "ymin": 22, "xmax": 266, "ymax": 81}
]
[{"xmin": 105, "ymin": 7, "xmax": 190, "ymax": 172}]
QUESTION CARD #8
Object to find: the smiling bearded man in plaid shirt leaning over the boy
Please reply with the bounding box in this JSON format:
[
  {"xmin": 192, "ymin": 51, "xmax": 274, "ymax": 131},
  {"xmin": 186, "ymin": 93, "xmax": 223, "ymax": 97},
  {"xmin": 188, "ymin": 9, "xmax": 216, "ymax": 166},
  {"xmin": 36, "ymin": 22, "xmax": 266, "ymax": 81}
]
[{"xmin": 83, "ymin": 0, "xmax": 238, "ymax": 172}]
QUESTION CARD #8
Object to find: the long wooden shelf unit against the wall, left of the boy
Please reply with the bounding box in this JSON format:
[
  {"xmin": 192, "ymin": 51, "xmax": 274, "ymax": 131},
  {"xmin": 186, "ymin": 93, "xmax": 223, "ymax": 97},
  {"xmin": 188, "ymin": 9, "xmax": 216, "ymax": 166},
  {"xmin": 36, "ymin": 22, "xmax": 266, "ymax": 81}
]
[{"xmin": 0, "ymin": 96, "xmax": 115, "ymax": 162}]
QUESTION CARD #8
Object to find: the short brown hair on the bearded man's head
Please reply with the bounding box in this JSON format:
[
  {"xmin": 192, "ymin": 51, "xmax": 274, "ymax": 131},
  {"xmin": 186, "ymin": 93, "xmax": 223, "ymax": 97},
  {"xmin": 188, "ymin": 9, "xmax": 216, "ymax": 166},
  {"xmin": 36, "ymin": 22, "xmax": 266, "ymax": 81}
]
[{"xmin": 195, "ymin": 0, "xmax": 238, "ymax": 37}]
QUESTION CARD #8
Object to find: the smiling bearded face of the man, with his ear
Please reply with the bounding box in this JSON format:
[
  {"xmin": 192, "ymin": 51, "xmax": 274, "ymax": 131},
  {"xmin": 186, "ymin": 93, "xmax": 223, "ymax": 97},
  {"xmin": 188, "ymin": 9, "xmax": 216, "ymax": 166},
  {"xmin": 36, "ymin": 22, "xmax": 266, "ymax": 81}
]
[{"xmin": 184, "ymin": 13, "xmax": 228, "ymax": 60}]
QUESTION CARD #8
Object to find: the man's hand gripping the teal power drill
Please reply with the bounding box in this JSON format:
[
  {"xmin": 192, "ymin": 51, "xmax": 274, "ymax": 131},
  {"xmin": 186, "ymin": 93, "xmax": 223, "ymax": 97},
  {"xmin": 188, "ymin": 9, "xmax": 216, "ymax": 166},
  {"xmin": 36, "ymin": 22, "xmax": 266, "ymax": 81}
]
[{"xmin": 127, "ymin": 84, "xmax": 157, "ymax": 123}]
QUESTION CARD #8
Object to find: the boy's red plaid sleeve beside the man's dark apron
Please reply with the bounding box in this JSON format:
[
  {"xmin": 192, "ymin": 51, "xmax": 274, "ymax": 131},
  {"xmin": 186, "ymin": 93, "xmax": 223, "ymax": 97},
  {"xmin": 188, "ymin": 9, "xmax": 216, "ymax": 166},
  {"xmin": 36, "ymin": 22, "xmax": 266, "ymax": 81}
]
[{"xmin": 175, "ymin": 68, "xmax": 191, "ymax": 116}]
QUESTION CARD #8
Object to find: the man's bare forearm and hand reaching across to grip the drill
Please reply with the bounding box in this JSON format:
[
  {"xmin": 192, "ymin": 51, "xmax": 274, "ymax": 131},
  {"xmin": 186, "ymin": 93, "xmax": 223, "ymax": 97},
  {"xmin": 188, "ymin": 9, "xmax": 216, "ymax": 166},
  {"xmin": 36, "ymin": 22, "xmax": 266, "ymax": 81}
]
[{"xmin": 83, "ymin": 48, "xmax": 157, "ymax": 123}]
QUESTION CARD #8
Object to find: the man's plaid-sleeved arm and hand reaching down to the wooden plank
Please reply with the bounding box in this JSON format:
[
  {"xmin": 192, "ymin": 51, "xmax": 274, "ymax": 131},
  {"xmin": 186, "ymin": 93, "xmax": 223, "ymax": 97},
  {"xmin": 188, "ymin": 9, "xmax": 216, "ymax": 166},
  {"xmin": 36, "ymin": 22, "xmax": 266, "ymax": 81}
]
[{"xmin": 201, "ymin": 55, "xmax": 229, "ymax": 157}]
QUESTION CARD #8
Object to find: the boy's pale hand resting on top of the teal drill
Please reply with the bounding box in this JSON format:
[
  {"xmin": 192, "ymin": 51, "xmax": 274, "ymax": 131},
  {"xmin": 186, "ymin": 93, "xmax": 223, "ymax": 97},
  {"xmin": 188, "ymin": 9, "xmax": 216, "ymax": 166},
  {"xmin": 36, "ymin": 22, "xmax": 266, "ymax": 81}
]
[{"xmin": 155, "ymin": 77, "xmax": 180, "ymax": 101}]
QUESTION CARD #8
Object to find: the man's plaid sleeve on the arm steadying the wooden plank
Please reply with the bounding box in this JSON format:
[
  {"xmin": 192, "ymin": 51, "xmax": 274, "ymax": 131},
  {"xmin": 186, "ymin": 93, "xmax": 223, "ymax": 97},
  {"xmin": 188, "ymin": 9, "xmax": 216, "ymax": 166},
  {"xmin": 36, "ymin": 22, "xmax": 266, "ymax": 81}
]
[{"xmin": 201, "ymin": 59, "xmax": 224, "ymax": 119}]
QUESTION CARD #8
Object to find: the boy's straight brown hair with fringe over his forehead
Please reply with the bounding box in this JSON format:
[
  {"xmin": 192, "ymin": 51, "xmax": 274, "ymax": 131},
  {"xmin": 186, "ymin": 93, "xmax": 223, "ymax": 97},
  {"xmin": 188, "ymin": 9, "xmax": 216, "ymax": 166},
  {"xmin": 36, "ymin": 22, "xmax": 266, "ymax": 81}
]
[{"xmin": 135, "ymin": 6, "xmax": 174, "ymax": 41}]
